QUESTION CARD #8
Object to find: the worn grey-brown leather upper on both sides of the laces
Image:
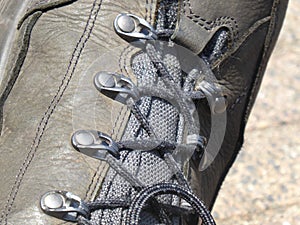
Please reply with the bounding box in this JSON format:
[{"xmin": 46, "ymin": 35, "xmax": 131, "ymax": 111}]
[{"xmin": 0, "ymin": 0, "xmax": 288, "ymax": 224}]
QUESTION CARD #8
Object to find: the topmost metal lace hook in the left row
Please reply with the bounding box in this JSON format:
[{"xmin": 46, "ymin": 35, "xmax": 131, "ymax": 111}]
[{"xmin": 114, "ymin": 13, "xmax": 157, "ymax": 41}]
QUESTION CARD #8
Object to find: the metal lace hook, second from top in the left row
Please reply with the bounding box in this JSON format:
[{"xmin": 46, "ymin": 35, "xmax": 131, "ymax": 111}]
[{"xmin": 94, "ymin": 72, "xmax": 140, "ymax": 104}]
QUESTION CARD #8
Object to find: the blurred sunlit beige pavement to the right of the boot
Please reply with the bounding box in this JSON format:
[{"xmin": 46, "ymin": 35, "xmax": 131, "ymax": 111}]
[{"xmin": 213, "ymin": 0, "xmax": 300, "ymax": 225}]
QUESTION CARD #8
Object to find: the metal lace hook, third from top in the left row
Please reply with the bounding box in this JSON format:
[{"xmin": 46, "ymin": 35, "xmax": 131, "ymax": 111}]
[{"xmin": 71, "ymin": 130, "xmax": 120, "ymax": 161}]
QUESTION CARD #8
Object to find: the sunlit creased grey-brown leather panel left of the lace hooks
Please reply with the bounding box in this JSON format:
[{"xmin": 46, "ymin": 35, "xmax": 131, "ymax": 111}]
[{"xmin": 0, "ymin": 0, "xmax": 156, "ymax": 224}]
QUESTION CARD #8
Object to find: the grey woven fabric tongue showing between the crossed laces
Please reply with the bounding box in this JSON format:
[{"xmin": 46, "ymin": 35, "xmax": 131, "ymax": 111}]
[{"xmin": 91, "ymin": 53, "xmax": 182, "ymax": 224}]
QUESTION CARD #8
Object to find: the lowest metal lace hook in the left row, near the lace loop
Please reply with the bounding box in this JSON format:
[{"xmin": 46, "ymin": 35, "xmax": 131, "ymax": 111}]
[{"xmin": 40, "ymin": 191, "xmax": 90, "ymax": 222}]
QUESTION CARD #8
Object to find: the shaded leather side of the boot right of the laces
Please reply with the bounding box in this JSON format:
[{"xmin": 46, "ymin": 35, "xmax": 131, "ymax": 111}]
[{"xmin": 182, "ymin": 0, "xmax": 288, "ymax": 211}]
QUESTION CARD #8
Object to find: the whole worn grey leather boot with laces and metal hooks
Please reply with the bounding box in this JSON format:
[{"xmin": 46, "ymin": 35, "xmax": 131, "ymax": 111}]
[{"xmin": 0, "ymin": 0, "xmax": 288, "ymax": 224}]
